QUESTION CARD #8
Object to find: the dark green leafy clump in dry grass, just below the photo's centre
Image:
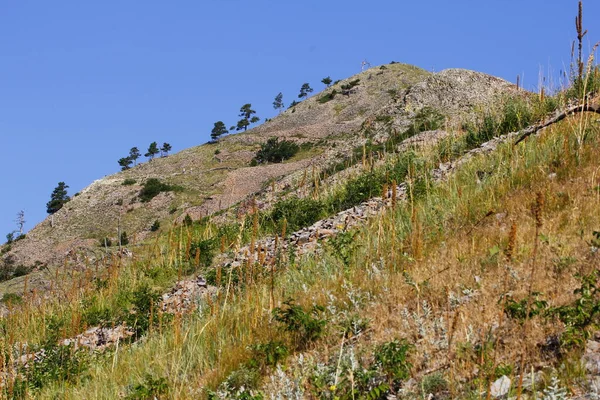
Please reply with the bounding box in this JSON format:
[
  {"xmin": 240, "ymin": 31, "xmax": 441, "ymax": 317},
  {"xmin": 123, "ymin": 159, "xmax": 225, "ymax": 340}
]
[{"xmin": 273, "ymin": 299, "xmax": 327, "ymax": 349}]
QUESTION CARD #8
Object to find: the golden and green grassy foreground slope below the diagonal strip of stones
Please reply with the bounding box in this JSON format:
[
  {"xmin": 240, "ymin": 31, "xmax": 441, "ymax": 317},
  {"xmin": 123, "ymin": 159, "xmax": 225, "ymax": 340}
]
[{"xmin": 22, "ymin": 108, "xmax": 600, "ymax": 398}]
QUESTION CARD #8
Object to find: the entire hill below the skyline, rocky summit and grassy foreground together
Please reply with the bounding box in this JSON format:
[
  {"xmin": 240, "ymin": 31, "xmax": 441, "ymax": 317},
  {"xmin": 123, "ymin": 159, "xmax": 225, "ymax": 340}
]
[{"xmin": 0, "ymin": 7, "xmax": 600, "ymax": 400}]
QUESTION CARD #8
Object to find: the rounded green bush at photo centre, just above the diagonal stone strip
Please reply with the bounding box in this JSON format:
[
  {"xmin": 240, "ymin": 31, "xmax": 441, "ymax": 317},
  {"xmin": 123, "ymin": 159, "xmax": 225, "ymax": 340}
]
[{"xmin": 271, "ymin": 196, "xmax": 325, "ymax": 232}]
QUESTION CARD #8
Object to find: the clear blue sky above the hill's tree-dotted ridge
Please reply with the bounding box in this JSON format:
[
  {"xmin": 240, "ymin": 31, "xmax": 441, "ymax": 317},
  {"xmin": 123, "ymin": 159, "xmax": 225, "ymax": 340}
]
[{"xmin": 0, "ymin": 0, "xmax": 600, "ymax": 238}]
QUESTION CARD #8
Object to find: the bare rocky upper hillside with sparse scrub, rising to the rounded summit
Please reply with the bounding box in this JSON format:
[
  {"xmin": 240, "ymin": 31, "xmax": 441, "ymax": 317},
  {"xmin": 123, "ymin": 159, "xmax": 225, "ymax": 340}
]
[{"xmin": 2, "ymin": 63, "xmax": 516, "ymax": 282}]
